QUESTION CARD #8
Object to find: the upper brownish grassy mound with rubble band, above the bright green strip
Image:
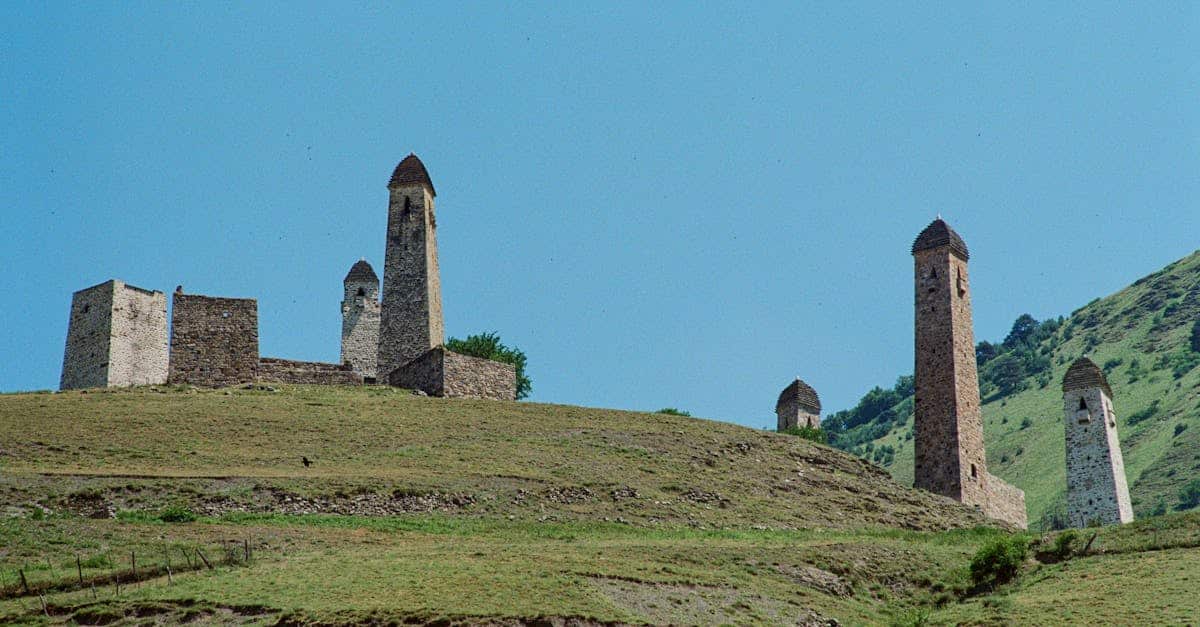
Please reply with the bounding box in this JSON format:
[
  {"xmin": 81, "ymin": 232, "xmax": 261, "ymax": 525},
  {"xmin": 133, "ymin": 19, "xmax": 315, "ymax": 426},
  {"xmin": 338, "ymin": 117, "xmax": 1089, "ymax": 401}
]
[{"xmin": 0, "ymin": 386, "xmax": 983, "ymax": 529}]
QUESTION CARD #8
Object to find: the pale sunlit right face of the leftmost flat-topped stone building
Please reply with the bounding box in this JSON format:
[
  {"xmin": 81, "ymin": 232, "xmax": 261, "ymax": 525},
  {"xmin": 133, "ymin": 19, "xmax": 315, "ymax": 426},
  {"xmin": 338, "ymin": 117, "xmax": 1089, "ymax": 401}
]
[{"xmin": 108, "ymin": 282, "xmax": 169, "ymax": 386}]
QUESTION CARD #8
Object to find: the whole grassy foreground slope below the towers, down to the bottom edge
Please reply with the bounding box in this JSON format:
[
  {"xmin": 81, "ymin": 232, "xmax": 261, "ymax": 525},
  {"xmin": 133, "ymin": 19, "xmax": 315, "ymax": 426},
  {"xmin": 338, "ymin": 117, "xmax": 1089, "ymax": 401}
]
[{"xmin": 0, "ymin": 387, "xmax": 1200, "ymax": 626}]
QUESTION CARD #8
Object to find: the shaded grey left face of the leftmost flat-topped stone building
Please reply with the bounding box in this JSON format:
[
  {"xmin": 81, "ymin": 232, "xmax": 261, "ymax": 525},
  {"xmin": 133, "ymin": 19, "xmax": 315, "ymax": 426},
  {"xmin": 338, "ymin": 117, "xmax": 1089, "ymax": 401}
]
[{"xmin": 59, "ymin": 281, "xmax": 115, "ymax": 389}]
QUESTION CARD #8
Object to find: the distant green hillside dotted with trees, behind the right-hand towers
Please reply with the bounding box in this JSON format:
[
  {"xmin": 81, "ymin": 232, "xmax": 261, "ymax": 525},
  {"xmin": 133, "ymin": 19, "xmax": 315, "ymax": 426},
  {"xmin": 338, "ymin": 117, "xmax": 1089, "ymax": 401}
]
[{"xmin": 841, "ymin": 252, "xmax": 1200, "ymax": 527}]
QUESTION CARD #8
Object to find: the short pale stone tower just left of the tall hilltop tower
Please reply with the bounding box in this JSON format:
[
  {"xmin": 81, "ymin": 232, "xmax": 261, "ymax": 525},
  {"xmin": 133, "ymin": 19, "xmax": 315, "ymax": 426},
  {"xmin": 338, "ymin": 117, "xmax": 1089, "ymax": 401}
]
[{"xmin": 342, "ymin": 259, "xmax": 379, "ymax": 383}]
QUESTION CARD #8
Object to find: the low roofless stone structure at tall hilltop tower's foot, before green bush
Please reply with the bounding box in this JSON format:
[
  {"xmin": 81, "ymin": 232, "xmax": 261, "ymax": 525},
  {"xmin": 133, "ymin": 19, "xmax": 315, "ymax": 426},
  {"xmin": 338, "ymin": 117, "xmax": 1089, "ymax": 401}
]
[{"xmin": 388, "ymin": 346, "xmax": 517, "ymax": 400}]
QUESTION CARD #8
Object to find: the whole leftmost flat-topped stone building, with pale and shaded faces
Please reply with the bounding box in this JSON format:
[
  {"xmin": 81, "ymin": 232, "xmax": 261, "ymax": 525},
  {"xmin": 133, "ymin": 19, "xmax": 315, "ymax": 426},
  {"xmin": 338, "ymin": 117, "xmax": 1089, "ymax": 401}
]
[{"xmin": 59, "ymin": 279, "xmax": 167, "ymax": 389}]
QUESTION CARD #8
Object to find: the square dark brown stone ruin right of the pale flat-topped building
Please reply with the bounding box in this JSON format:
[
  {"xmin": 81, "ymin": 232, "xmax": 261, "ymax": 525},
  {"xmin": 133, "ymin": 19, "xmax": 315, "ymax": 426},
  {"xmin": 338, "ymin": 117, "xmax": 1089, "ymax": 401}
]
[{"xmin": 168, "ymin": 292, "xmax": 258, "ymax": 387}]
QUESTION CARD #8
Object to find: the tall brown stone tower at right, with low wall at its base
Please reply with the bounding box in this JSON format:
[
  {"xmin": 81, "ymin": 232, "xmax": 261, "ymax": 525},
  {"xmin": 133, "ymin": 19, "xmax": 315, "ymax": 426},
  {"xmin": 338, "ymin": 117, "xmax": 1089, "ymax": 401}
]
[{"xmin": 912, "ymin": 217, "xmax": 1026, "ymax": 527}]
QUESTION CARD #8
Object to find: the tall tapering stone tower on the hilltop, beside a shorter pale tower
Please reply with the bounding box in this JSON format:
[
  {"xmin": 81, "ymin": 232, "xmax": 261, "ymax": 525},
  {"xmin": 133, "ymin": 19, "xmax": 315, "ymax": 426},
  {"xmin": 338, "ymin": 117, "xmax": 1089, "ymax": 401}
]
[{"xmin": 377, "ymin": 155, "xmax": 445, "ymax": 378}]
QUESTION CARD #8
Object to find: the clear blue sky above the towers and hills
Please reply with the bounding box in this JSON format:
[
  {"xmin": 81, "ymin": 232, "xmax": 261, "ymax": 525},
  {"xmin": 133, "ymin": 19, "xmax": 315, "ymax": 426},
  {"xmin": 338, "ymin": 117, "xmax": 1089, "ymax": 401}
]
[{"xmin": 0, "ymin": 2, "xmax": 1200, "ymax": 426}]
